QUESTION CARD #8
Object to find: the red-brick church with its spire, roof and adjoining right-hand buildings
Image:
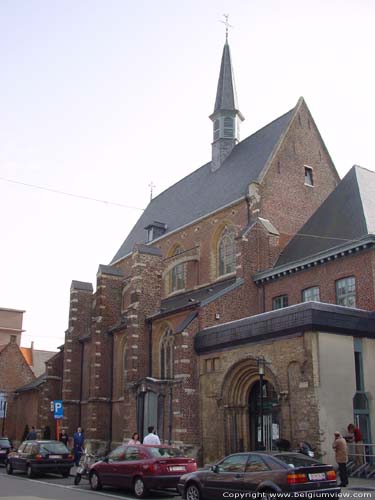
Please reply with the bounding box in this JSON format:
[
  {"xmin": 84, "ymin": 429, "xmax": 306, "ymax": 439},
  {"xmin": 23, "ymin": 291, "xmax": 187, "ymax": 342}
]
[{"xmin": 17, "ymin": 41, "xmax": 375, "ymax": 463}]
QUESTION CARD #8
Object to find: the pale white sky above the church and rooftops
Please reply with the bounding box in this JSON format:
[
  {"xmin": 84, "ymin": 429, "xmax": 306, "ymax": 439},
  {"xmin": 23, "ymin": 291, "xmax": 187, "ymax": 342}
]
[{"xmin": 0, "ymin": 0, "xmax": 375, "ymax": 350}]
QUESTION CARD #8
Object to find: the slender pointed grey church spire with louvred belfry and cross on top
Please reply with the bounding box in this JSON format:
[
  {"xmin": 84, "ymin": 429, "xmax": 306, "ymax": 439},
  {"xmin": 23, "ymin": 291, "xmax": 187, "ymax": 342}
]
[{"xmin": 210, "ymin": 15, "xmax": 244, "ymax": 170}]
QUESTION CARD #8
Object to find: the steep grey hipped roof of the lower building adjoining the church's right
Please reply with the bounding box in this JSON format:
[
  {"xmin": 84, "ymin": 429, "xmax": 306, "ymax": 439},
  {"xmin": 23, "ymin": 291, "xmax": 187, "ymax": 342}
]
[{"xmin": 275, "ymin": 165, "xmax": 375, "ymax": 267}]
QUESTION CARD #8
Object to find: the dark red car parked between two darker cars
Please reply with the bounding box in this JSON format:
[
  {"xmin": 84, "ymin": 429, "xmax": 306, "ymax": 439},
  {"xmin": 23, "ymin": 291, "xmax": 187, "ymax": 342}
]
[{"xmin": 89, "ymin": 445, "xmax": 197, "ymax": 498}]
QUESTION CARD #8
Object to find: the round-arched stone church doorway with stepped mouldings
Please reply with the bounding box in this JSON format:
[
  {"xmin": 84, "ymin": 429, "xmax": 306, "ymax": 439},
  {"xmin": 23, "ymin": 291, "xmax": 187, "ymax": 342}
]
[{"xmin": 222, "ymin": 357, "xmax": 280, "ymax": 454}]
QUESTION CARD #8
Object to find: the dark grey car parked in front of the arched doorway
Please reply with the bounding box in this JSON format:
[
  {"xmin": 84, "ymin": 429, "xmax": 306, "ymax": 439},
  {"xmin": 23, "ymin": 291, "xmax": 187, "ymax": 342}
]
[{"xmin": 178, "ymin": 452, "xmax": 341, "ymax": 500}]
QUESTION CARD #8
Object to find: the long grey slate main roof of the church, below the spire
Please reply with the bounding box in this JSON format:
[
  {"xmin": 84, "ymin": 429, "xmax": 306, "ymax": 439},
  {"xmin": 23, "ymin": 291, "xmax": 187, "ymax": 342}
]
[{"xmin": 111, "ymin": 104, "xmax": 301, "ymax": 264}]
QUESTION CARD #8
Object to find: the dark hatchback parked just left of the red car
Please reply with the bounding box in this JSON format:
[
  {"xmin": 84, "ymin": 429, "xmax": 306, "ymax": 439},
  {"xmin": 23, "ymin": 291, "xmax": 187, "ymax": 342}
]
[{"xmin": 6, "ymin": 440, "xmax": 74, "ymax": 478}]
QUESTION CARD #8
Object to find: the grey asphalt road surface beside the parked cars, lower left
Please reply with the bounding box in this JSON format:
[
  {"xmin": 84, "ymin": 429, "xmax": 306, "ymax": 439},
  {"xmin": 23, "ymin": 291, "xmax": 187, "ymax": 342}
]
[{"xmin": 0, "ymin": 467, "xmax": 181, "ymax": 500}]
